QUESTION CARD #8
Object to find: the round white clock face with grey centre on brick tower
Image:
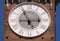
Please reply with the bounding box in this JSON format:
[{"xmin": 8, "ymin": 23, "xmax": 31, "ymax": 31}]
[{"xmin": 8, "ymin": 2, "xmax": 51, "ymax": 37}]
